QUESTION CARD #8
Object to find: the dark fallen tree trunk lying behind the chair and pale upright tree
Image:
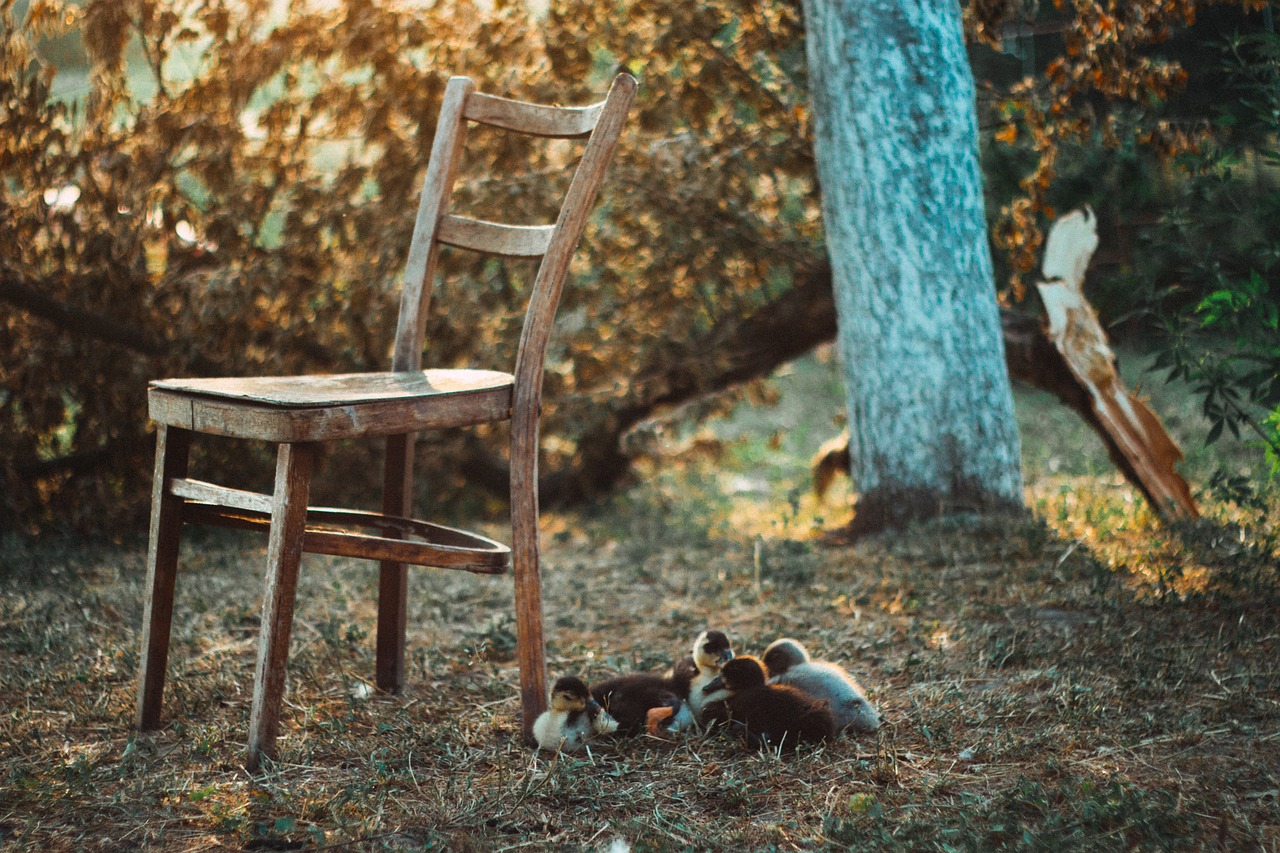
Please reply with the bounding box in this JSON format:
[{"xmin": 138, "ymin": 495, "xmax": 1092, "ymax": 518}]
[{"xmin": 0, "ymin": 239, "xmax": 1196, "ymax": 517}]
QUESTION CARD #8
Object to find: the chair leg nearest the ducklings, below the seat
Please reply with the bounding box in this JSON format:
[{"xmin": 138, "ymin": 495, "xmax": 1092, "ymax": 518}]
[{"xmin": 511, "ymin": 409, "xmax": 547, "ymax": 744}]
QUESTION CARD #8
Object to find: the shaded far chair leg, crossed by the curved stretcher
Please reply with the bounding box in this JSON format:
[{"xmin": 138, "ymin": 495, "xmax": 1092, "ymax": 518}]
[{"xmin": 376, "ymin": 433, "xmax": 413, "ymax": 693}]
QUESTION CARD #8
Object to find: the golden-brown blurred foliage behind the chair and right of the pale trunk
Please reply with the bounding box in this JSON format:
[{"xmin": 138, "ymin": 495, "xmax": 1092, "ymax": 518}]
[{"xmin": 0, "ymin": 0, "xmax": 1280, "ymax": 530}]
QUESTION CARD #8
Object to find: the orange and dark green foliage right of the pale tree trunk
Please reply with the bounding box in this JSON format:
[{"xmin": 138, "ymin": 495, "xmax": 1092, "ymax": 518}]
[{"xmin": 972, "ymin": 3, "xmax": 1280, "ymax": 479}]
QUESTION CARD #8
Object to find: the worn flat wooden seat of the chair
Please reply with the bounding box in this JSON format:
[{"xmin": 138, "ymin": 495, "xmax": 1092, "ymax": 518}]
[{"xmin": 147, "ymin": 369, "xmax": 515, "ymax": 443}]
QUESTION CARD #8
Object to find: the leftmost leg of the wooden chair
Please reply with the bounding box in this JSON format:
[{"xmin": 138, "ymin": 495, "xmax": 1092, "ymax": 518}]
[{"xmin": 134, "ymin": 424, "xmax": 191, "ymax": 731}]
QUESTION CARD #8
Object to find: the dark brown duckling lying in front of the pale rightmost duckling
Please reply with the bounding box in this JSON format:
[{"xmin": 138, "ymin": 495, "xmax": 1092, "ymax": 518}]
[{"xmin": 703, "ymin": 654, "xmax": 836, "ymax": 751}]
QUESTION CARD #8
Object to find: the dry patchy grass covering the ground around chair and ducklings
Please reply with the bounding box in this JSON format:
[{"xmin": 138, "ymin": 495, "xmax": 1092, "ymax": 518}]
[{"xmin": 0, "ymin": 345, "xmax": 1280, "ymax": 850}]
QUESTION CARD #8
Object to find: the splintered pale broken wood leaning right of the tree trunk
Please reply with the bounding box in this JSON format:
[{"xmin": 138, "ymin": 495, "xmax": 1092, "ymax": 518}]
[{"xmin": 1037, "ymin": 207, "xmax": 1199, "ymax": 521}]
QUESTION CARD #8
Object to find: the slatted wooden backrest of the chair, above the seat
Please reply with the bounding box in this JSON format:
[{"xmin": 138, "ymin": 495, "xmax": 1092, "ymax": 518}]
[{"xmin": 392, "ymin": 74, "xmax": 636, "ymax": 398}]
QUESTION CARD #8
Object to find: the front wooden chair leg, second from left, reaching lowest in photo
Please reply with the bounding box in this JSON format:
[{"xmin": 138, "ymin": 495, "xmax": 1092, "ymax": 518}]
[{"xmin": 244, "ymin": 444, "xmax": 315, "ymax": 772}]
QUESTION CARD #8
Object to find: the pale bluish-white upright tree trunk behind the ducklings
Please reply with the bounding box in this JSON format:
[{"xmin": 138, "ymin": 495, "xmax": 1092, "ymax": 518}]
[{"xmin": 804, "ymin": 0, "xmax": 1023, "ymax": 533}]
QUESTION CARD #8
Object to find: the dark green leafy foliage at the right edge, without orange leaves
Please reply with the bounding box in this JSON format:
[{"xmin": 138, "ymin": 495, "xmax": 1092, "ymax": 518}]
[{"xmin": 1144, "ymin": 33, "xmax": 1280, "ymax": 471}]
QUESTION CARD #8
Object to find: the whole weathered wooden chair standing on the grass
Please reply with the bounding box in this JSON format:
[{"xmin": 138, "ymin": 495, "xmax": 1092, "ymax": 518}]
[{"xmin": 136, "ymin": 74, "xmax": 636, "ymax": 770}]
